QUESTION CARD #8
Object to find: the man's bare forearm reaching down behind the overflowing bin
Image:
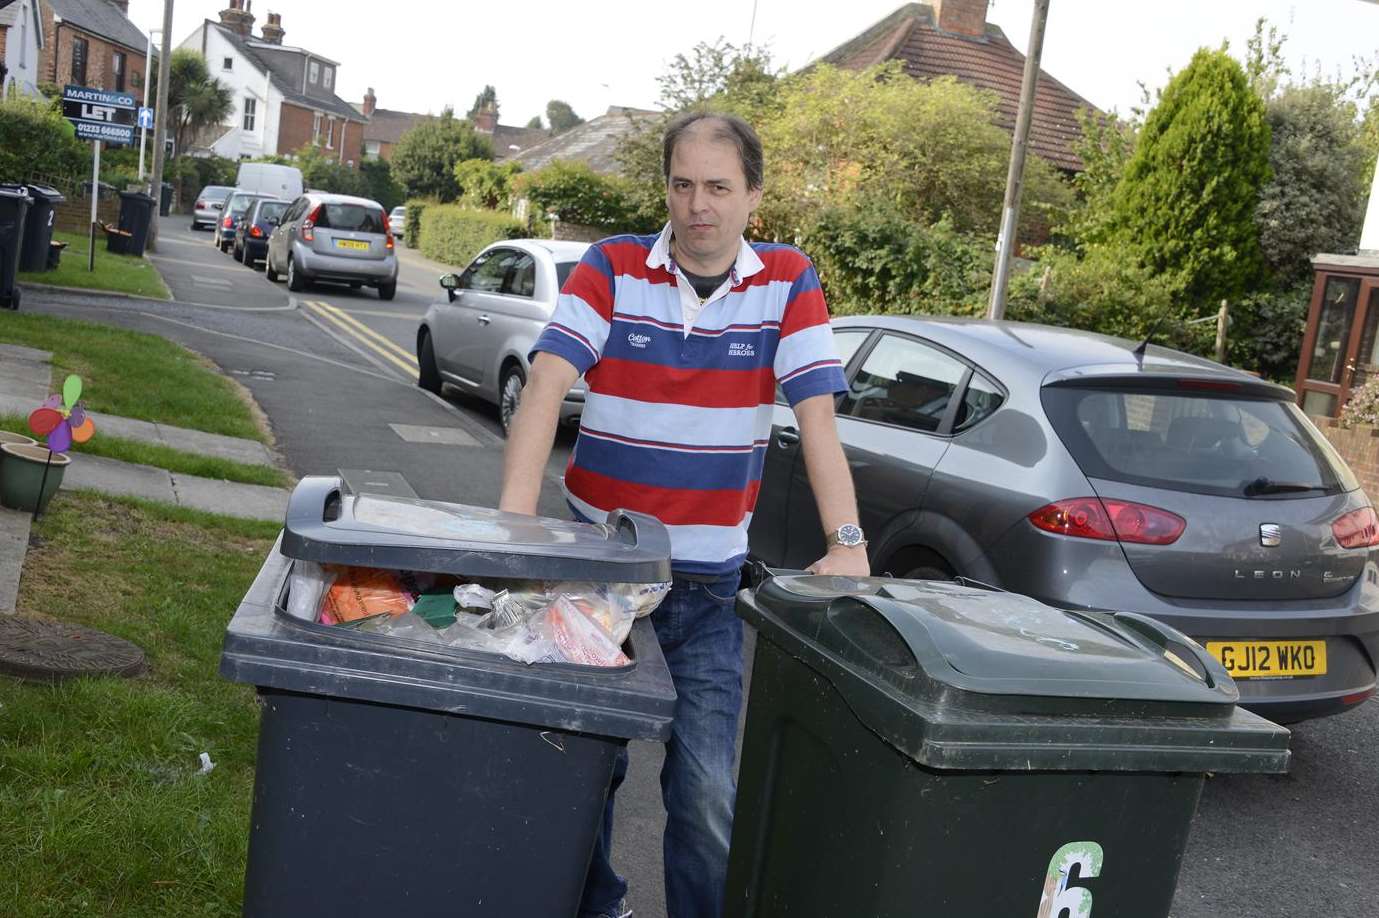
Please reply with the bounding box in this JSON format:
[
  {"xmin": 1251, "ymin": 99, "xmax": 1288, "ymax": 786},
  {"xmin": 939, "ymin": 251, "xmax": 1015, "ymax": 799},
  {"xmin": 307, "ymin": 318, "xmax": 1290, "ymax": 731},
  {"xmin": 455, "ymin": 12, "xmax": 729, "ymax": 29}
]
[{"xmin": 498, "ymin": 351, "xmax": 579, "ymax": 516}]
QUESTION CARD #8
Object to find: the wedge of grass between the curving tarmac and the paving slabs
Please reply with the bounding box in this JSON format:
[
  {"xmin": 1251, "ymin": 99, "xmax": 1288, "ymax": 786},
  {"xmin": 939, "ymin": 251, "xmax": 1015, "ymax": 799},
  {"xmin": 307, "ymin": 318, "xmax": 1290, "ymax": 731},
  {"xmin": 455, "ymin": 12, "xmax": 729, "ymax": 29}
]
[{"xmin": 0, "ymin": 312, "xmax": 266, "ymax": 441}]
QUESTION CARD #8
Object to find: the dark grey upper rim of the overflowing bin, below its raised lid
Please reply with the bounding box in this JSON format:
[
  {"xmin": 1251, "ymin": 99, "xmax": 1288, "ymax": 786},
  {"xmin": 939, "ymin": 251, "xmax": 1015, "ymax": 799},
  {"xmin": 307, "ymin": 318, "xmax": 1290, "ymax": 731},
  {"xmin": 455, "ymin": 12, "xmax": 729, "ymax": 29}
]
[{"xmin": 221, "ymin": 536, "xmax": 676, "ymax": 738}]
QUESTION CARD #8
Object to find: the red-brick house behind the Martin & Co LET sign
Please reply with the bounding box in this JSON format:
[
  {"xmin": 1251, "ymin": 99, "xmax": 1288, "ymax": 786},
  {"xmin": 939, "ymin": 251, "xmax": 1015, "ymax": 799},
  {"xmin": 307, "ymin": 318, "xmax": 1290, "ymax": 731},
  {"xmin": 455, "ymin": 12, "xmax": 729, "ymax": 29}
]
[{"xmin": 39, "ymin": 0, "xmax": 149, "ymax": 95}]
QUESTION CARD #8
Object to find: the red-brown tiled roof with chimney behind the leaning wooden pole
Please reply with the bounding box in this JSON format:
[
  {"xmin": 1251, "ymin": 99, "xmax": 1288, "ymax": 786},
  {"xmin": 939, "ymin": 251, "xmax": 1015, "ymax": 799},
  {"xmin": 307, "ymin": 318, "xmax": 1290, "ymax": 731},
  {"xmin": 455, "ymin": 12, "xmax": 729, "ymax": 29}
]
[{"xmin": 819, "ymin": 0, "xmax": 1098, "ymax": 172}]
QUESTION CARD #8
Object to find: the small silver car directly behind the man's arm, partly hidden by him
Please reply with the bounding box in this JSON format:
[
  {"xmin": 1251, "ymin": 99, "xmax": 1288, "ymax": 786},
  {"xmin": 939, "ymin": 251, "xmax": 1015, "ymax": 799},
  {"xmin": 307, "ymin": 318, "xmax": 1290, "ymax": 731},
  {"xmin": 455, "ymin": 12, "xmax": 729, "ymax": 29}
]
[{"xmin": 416, "ymin": 238, "xmax": 589, "ymax": 431}]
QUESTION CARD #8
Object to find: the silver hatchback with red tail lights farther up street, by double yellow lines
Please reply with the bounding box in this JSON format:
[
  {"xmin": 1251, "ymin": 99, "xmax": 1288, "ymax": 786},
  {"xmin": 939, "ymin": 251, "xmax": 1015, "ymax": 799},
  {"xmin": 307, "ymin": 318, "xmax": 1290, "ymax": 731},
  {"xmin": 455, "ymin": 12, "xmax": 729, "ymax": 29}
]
[{"xmin": 263, "ymin": 192, "xmax": 397, "ymax": 299}]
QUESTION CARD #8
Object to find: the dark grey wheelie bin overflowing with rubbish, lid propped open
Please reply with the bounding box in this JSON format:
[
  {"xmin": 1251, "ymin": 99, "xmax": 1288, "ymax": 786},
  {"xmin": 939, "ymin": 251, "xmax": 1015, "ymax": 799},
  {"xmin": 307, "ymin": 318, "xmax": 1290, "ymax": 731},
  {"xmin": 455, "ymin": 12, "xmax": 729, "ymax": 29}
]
[{"xmin": 221, "ymin": 477, "xmax": 674, "ymax": 918}]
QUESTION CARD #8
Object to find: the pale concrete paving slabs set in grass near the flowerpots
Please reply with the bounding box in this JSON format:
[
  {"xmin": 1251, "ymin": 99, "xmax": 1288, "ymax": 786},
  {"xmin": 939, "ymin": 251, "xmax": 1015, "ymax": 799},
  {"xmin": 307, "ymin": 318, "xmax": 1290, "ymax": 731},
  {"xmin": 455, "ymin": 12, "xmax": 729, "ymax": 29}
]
[{"xmin": 0, "ymin": 345, "xmax": 290, "ymax": 612}]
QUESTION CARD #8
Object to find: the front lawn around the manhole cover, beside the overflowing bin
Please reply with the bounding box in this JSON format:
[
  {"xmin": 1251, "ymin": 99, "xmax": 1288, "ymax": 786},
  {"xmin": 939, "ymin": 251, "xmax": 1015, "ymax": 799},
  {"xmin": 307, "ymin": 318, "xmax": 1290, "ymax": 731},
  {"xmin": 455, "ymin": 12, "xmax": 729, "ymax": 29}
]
[{"xmin": 0, "ymin": 491, "xmax": 277, "ymax": 918}]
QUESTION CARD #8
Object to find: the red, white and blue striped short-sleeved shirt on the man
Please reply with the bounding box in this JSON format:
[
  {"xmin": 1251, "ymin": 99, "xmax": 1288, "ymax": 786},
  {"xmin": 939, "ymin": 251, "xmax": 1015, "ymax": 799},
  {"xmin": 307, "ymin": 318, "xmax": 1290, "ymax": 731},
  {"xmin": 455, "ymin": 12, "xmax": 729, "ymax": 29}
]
[{"xmin": 532, "ymin": 225, "xmax": 845, "ymax": 575}]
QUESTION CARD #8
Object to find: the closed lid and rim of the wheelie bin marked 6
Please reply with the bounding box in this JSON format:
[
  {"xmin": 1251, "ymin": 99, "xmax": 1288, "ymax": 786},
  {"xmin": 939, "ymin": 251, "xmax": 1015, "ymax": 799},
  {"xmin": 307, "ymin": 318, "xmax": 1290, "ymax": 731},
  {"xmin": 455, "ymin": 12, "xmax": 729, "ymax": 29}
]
[{"xmin": 738, "ymin": 575, "xmax": 1288, "ymax": 772}]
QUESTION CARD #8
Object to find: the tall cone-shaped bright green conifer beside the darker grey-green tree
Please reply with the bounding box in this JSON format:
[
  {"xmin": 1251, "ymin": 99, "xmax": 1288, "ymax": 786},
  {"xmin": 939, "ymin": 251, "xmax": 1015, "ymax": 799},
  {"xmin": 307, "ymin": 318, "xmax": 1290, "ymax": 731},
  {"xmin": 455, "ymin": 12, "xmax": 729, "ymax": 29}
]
[{"xmin": 1111, "ymin": 48, "xmax": 1269, "ymax": 307}]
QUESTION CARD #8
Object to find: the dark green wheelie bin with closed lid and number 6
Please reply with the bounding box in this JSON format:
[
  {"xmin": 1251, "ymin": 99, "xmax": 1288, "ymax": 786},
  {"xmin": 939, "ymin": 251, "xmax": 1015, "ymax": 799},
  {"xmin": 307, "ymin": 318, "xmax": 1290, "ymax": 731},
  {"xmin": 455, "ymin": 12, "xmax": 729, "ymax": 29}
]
[{"xmin": 724, "ymin": 576, "xmax": 1288, "ymax": 918}]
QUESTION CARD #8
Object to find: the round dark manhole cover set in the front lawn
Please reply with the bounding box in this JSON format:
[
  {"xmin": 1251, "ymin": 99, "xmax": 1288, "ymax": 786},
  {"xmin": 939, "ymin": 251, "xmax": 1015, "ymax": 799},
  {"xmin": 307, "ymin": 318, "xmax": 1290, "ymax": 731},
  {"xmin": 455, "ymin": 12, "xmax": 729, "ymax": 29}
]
[{"xmin": 0, "ymin": 615, "xmax": 145, "ymax": 682}]
